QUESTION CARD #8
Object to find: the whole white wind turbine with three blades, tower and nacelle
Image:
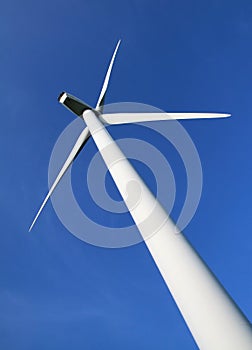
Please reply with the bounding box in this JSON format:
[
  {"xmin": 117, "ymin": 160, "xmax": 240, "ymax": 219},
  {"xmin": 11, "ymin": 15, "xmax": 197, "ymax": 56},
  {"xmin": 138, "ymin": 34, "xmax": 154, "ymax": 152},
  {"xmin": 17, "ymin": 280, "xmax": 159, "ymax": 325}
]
[{"xmin": 29, "ymin": 41, "xmax": 252, "ymax": 350}]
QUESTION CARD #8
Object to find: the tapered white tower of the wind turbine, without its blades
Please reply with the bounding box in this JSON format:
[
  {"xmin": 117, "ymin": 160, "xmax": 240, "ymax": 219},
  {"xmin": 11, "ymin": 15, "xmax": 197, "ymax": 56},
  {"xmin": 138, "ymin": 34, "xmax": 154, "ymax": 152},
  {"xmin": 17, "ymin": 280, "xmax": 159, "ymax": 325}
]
[{"xmin": 83, "ymin": 110, "xmax": 252, "ymax": 350}]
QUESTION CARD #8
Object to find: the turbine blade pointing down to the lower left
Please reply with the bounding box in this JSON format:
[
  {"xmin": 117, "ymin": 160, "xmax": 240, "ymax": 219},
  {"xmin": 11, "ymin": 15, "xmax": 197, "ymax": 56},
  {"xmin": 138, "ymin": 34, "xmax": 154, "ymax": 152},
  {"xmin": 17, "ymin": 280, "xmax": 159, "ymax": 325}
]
[{"xmin": 29, "ymin": 127, "xmax": 90, "ymax": 232}]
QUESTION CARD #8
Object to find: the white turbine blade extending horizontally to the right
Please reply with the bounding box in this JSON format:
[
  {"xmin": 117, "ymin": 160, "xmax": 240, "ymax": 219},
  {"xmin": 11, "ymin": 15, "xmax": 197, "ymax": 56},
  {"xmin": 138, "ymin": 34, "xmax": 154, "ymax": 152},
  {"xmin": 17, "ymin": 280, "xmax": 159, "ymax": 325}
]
[{"xmin": 100, "ymin": 112, "xmax": 230, "ymax": 124}]
